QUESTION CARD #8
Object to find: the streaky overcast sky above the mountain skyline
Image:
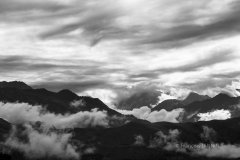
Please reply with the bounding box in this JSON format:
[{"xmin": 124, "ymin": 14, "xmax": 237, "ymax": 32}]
[{"xmin": 0, "ymin": 0, "xmax": 240, "ymax": 104}]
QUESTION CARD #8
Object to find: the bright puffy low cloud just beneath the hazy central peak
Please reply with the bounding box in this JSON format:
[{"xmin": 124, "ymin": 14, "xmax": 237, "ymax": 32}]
[{"xmin": 117, "ymin": 106, "xmax": 184, "ymax": 123}]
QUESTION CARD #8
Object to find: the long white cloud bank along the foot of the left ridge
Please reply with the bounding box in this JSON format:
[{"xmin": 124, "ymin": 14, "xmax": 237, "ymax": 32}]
[{"xmin": 0, "ymin": 102, "xmax": 108, "ymax": 128}]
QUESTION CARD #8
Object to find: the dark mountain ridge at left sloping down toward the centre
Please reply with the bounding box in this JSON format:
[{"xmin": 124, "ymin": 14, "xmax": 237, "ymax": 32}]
[{"xmin": 0, "ymin": 88, "xmax": 121, "ymax": 115}]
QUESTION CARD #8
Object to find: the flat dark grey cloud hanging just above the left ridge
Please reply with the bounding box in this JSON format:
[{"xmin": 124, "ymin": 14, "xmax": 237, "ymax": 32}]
[{"xmin": 31, "ymin": 79, "xmax": 110, "ymax": 93}]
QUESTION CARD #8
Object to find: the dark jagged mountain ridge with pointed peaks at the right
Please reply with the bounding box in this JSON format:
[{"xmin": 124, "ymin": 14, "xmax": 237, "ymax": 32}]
[{"xmin": 152, "ymin": 93, "xmax": 240, "ymax": 122}]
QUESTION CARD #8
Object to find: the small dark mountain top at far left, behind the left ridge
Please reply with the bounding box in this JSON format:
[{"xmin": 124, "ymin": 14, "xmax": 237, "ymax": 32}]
[{"xmin": 0, "ymin": 81, "xmax": 32, "ymax": 89}]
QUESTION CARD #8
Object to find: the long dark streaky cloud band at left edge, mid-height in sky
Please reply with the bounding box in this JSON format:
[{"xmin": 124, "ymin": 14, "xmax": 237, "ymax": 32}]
[{"xmin": 0, "ymin": 55, "xmax": 109, "ymax": 75}]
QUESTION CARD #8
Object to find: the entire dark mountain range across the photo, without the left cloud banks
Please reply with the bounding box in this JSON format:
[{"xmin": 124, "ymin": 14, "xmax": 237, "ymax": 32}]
[{"xmin": 0, "ymin": 81, "xmax": 240, "ymax": 160}]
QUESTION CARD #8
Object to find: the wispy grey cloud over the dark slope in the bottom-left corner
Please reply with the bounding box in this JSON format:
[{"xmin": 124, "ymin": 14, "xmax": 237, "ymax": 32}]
[{"xmin": 3, "ymin": 124, "xmax": 80, "ymax": 159}]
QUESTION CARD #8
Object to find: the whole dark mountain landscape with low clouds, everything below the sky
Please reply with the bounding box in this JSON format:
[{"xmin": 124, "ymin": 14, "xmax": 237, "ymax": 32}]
[{"xmin": 0, "ymin": 81, "xmax": 240, "ymax": 160}]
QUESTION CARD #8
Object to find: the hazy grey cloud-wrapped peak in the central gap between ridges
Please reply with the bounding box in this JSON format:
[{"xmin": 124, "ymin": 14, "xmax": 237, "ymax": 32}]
[{"xmin": 117, "ymin": 91, "xmax": 161, "ymax": 110}]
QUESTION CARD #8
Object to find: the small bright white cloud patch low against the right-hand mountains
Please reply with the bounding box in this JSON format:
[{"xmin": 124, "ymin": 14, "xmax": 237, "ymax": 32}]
[{"xmin": 197, "ymin": 109, "xmax": 231, "ymax": 121}]
